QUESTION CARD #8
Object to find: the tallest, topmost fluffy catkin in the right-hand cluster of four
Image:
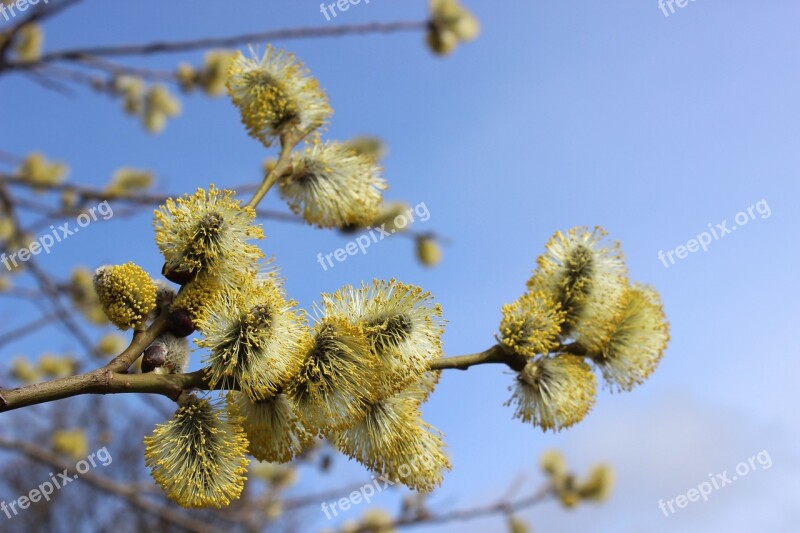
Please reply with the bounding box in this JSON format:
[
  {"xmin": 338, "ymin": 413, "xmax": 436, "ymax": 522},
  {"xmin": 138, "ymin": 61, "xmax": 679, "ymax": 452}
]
[{"xmin": 528, "ymin": 227, "xmax": 628, "ymax": 350}]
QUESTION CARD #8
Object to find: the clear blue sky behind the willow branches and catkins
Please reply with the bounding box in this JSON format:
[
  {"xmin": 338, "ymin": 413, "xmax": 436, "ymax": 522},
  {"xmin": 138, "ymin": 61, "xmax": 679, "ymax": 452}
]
[{"xmin": 0, "ymin": 0, "xmax": 800, "ymax": 532}]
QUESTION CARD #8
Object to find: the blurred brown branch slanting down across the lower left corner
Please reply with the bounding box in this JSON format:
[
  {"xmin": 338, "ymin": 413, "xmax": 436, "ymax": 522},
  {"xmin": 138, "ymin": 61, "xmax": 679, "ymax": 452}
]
[{"xmin": 0, "ymin": 436, "xmax": 220, "ymax": 533}]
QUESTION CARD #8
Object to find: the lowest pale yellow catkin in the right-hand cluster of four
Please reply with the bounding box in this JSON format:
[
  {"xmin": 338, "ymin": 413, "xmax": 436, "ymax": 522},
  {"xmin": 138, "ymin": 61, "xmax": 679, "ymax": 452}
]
[{"xmin": 506, "ymin": 355, "xmax": 597, "ymax": 431}]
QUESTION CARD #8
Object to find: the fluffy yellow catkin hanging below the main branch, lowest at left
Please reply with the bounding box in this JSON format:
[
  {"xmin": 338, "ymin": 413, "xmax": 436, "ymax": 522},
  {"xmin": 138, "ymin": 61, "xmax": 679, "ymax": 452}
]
[{"xmin": 144, "ymin": 398, "xmax": 249, "ymax": 508}]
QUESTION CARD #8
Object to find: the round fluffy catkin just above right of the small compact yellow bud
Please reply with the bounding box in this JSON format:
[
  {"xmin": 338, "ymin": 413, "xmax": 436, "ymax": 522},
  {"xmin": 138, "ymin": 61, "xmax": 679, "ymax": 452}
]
[{"xmin": 153, "ymin": 185, "xmax": 264, "ymax": 285}]
